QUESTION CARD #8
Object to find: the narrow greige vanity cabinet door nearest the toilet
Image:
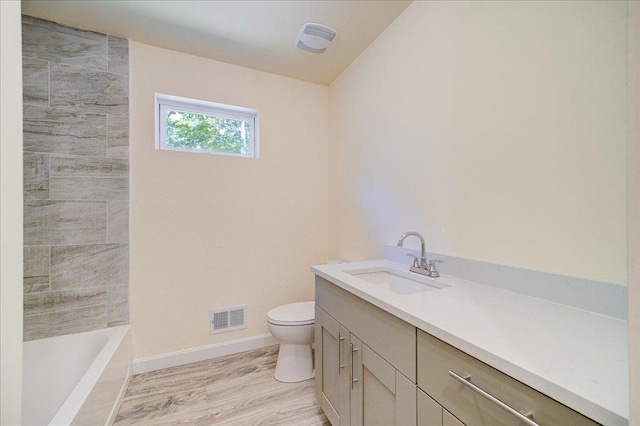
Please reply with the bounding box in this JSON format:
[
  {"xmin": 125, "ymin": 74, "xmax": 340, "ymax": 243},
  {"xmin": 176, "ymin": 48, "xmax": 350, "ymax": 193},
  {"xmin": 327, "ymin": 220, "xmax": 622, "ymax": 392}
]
[{"xmin": 315, "ymin": 306, "xmax": 350, "ymax": 426}]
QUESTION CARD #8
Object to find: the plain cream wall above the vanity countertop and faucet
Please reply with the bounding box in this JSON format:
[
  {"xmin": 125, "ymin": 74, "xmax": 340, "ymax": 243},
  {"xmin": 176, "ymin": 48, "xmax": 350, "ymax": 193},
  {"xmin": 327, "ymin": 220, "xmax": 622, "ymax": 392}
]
[{"xmin": 329, "ymin": 2, "xmax": 626, "ymax": 282}]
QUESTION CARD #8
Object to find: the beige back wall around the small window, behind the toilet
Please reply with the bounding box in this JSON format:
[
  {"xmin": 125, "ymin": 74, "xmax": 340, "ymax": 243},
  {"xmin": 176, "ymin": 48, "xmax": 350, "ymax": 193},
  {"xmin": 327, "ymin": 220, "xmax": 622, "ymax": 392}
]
[{"xmin": 130, "ymin": 42, "xmax": 328, "ymax": 358}]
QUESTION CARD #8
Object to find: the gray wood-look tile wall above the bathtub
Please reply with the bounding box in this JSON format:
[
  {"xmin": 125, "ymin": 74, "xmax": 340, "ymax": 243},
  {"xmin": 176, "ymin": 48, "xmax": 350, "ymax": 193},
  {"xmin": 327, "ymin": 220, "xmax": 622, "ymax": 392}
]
[{"xmin": 22, "ymin": 16, "xmax": 129, "ymax": 340}]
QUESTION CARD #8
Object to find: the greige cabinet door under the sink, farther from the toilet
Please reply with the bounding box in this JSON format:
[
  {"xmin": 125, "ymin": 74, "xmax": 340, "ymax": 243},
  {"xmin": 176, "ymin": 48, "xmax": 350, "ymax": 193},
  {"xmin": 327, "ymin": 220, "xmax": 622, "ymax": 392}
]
[{"xmin": 350, "ymin": 334, "xmax": 416, "ymax": 426}]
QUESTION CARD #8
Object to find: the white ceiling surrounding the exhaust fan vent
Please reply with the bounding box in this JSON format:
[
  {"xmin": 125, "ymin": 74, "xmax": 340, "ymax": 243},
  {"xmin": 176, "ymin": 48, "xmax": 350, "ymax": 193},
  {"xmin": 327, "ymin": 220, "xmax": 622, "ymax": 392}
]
[{"xmin": 22, "ymin": 0, "xmax": 411, "ymax": 85}]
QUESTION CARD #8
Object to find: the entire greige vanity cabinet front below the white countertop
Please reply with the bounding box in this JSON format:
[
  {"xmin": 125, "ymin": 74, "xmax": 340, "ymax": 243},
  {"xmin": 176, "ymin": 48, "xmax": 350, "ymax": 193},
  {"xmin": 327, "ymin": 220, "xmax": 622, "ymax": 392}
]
[{"xmin": 315, "ymin": 276, "xmax": 598, "ymax": 426}]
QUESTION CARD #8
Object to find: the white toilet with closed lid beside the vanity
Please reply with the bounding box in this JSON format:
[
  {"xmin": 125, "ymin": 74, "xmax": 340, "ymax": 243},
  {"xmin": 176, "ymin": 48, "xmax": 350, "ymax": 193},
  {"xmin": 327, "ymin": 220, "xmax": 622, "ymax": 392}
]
[{"xmin": 267, "ymin": 302, "xmax": 315, "ymax": 383}]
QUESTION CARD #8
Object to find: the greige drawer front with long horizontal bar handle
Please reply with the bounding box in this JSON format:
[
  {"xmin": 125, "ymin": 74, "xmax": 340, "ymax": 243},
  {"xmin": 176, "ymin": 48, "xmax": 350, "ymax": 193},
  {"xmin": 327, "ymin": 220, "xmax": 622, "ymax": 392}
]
[{"xmin": 417, "ymin": 330, "xmax": 598, "ymax": 426}]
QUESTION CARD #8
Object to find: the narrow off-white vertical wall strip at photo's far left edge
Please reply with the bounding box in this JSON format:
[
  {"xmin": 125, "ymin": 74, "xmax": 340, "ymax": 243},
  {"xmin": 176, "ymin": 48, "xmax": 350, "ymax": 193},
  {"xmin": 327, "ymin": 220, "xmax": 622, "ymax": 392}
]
[{"xmin": 0, "ymin": 1, "xmax": 22, "ymax": 425}]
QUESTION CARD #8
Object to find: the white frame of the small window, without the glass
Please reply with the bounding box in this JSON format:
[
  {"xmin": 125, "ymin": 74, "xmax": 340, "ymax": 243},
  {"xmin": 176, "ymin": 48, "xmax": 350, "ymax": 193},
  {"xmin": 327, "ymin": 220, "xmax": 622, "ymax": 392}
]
[{"xmin": 155, "ymin": 93, "xmax": 259, "ymax": 158}]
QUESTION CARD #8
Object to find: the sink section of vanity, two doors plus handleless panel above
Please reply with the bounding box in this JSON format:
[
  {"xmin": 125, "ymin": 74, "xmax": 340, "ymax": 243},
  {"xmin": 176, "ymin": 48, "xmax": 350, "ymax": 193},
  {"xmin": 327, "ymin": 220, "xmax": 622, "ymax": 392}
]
[{"xmin": 315, "ymin": 277, "xmax": 417, "ymax": 426}]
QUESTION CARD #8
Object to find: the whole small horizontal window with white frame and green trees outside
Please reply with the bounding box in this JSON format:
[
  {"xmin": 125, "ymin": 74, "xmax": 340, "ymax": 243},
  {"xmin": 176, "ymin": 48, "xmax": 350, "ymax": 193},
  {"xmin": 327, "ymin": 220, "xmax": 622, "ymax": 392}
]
[{"xmin": 156, "ymin": 93, "xmax": 258, "ymax": 158}]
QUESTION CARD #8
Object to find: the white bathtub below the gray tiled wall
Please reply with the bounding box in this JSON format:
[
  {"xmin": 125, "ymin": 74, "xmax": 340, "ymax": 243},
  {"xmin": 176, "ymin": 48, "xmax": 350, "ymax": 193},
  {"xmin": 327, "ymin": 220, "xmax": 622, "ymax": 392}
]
[{"xmin": 22, "ymin": 325, "xmax": 131, "ymax": 426}]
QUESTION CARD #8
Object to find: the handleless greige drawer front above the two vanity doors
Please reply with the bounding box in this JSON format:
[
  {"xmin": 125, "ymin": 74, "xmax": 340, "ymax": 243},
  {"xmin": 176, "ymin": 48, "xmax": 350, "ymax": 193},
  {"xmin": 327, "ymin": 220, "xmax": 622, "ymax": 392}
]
[{"xmin": 316, "ymin": 276, "xmax": 416, "ymax": 383}]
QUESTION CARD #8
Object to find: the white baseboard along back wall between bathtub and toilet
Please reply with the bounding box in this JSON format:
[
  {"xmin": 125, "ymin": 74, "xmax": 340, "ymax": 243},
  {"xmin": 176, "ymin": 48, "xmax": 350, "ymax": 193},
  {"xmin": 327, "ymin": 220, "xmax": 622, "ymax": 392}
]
[{"xmin": 131, "ymin": 334, "xmax": 279, "ymax": 374}]
